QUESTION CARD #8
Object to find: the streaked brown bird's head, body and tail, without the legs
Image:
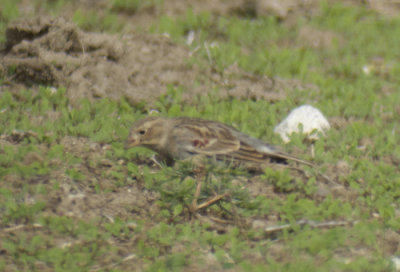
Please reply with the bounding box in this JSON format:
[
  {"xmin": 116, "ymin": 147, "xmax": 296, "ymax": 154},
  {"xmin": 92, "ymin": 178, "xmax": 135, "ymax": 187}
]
[{"xmin": 126, "ymin": 117, "xmax": 312, "ymax": 165}]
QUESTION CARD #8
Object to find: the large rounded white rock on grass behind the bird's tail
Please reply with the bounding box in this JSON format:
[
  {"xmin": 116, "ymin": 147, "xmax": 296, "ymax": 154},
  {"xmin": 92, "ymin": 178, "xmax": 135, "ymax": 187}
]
[{"xmin": 274, "ymin": 105, "xmax": 331, "ymax": 143}]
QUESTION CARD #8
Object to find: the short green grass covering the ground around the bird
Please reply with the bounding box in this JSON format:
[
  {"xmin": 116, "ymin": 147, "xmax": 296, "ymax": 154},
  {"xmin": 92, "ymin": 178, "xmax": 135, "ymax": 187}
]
[{"xmin": 0, "ymin": 1, "xmax": 400, "ymax": 271}]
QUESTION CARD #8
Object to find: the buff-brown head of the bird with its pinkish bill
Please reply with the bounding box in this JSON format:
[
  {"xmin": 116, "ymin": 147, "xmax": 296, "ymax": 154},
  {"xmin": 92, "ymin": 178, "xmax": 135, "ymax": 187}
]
[{"xmin": 125, "ymin": 117, "xmax": 168, "ymax": 151}]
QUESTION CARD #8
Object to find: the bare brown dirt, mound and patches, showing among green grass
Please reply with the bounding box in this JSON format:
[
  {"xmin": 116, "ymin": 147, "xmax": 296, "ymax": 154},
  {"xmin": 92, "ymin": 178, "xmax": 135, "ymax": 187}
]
[{"xmin": 0, "ymin": 0, "xmax": 400, "ymax": 271}]
